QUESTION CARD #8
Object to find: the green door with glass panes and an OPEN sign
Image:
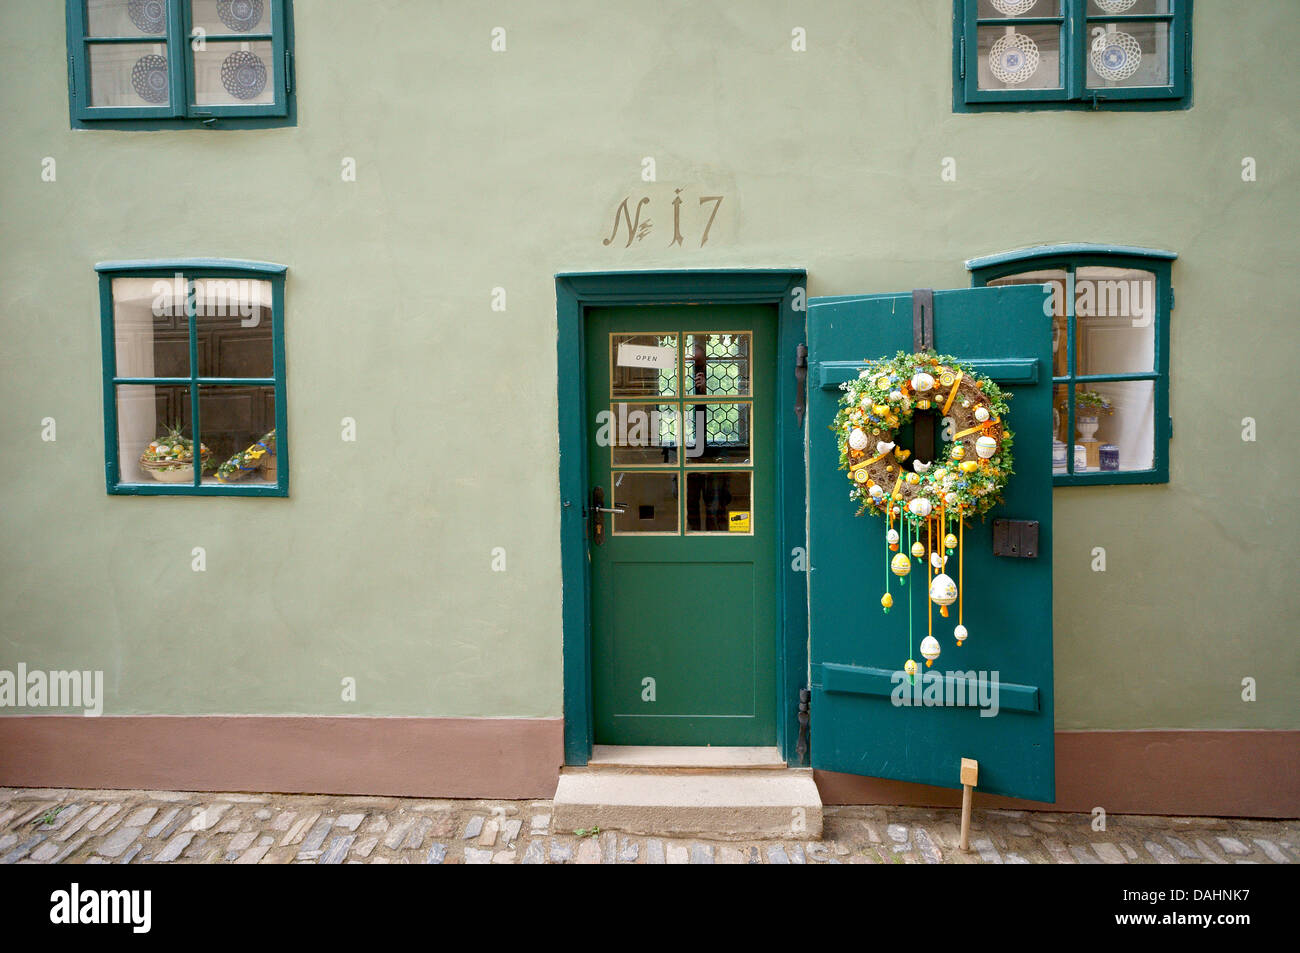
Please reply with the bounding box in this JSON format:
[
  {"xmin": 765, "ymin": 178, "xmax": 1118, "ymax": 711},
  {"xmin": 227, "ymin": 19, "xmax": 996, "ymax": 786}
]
[{"xmin": 586, "ymin": 306, "xmax": 777, "ymax": 745}]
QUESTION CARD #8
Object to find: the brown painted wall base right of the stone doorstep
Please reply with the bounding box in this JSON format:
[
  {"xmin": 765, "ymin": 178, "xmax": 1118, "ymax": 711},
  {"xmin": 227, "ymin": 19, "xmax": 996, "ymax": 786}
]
[{"xmin": 814, "ymin": 731, "xmax": 1300, "ymax": 818}]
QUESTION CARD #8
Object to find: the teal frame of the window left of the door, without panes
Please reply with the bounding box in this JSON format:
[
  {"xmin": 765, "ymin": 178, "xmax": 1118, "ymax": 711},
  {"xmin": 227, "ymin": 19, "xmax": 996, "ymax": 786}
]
[{"xmin": 95, "ymin": 259, "xmax": 289, "ymax": 497}]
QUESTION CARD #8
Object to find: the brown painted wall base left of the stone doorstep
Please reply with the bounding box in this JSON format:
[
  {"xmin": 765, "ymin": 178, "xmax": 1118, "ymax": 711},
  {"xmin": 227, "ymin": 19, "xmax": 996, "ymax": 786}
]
[{"xmin": 0, "ymin": 715, "xmax": 564, "ymax": 798}]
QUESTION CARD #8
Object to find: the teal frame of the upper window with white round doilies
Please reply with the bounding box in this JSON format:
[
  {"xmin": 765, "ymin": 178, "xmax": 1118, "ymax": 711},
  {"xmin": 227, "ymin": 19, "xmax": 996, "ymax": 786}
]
[{"xmin": 953, "ymin": 0, "xmax": 1192, "ymax": 112}]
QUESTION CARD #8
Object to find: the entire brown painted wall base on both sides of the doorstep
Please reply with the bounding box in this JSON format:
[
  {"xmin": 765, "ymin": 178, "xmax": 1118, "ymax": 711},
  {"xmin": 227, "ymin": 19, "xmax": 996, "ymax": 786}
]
[{"xmin": 0, "ymin": 715, "xmax": 1300, "ymax": 818}]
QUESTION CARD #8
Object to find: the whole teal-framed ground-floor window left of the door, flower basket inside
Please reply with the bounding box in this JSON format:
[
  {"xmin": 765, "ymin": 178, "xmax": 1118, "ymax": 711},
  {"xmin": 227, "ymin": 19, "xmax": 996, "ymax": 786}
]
[{"xmin": 95, "ymin": 259, "xmax": 289, "ymax": 497}]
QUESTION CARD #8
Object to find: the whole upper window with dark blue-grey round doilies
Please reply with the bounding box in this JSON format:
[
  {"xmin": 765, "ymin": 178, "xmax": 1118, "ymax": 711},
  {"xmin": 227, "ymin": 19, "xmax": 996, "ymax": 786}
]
[{"xmin": 68, "ymin": 0, "xmax": 293, "ymax": 127}]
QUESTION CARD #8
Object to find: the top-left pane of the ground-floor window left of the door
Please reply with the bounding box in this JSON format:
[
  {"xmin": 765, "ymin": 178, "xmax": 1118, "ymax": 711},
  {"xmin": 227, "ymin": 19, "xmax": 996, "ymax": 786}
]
[{"xmin": 113, "ymin": 277, "xmax": 190, "ymax": 377}]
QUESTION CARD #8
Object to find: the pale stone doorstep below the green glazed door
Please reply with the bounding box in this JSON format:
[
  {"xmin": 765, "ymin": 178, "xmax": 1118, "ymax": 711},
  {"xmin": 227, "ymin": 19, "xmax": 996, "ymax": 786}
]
[{"xmin": 551, "ymin": 766, "xmax": 822, "ymax": 840}]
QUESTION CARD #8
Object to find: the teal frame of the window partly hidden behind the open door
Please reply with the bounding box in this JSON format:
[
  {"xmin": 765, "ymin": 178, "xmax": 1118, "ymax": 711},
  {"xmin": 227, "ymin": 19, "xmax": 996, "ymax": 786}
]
[{"xmin": 966, "ymin": 243, "xmax": 1178, "ymax": 486}]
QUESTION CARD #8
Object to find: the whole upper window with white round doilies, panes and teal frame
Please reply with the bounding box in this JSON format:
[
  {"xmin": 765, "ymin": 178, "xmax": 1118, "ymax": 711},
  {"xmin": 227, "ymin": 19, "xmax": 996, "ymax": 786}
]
[{"xmin": 953, "ymin": 0, "xmax": 1192, "ymax": 112}]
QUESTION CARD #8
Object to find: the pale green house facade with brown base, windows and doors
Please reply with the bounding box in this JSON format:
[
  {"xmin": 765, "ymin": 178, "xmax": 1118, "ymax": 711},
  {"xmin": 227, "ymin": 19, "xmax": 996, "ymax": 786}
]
[{"xmin": 0, "ymin": 0, "xmax": 1300, "ymax": 815}]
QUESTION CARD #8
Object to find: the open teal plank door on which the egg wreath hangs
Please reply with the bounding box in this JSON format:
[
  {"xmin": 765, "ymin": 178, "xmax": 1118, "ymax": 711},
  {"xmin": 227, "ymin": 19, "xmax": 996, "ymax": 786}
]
[{"xmin": 809, "ymin": 286, "xmax": 1056, "ymax": 801}]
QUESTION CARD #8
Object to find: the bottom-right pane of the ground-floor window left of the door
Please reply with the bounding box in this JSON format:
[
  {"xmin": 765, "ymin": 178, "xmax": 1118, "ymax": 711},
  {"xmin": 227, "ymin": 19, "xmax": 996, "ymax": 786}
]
[{"xmin": 199, "ymin": 386, "xmax": 276, "ymax": 484}]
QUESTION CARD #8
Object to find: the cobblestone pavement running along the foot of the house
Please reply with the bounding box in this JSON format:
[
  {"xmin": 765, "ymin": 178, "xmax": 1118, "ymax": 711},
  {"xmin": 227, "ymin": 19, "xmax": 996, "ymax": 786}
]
[{"xmin": 0, "ymin": 788, "xmax": 1300, "ymax": 865}]
